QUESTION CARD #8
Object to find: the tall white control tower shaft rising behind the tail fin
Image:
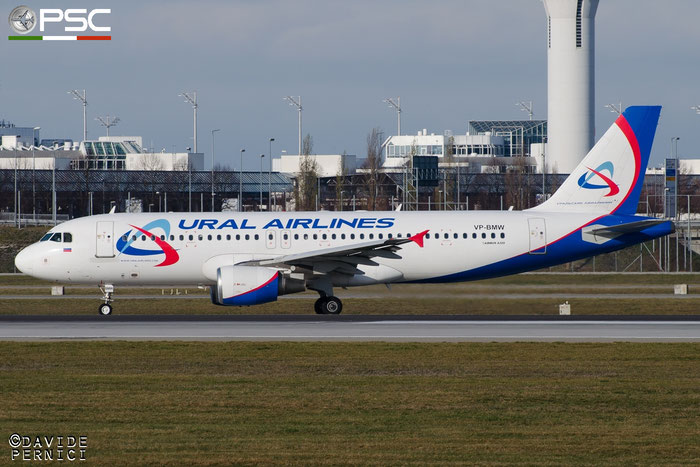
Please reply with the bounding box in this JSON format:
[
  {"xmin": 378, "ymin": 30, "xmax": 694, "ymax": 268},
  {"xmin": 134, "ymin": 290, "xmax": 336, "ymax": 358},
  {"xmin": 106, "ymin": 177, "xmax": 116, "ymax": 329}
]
[{"xmin": 543, "ymin": 0, "xmax": 598, "ymax": 174}]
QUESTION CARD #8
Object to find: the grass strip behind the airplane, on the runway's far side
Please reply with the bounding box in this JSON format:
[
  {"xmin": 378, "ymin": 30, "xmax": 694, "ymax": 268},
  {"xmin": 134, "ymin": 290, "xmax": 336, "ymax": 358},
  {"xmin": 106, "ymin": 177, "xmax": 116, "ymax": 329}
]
[{"xmin": 0, "ymin": 273, "xmax": 700, "ymax": 315}]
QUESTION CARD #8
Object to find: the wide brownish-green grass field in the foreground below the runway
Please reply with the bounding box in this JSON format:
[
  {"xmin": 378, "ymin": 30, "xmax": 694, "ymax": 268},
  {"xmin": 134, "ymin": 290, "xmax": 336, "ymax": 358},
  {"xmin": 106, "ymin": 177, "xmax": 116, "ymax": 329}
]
[{"xmin": 0, "ymin": 342, "xmax": 700, "ymax": 465}]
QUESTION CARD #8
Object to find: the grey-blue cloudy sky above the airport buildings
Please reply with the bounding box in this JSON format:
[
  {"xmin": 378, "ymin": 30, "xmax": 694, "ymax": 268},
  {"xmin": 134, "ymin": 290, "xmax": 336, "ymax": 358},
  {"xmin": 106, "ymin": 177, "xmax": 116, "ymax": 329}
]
[{"xmin": 0, "ymin": 0, "xmax": 700, "ymax": 169}]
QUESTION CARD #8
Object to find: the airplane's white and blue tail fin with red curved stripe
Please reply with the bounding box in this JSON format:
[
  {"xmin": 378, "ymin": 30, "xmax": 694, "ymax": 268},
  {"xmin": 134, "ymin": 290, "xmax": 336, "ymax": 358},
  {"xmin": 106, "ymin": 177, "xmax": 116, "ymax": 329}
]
[{"xmin": 532, "ymin": 106, "xmax": 661, "ymax": 215}]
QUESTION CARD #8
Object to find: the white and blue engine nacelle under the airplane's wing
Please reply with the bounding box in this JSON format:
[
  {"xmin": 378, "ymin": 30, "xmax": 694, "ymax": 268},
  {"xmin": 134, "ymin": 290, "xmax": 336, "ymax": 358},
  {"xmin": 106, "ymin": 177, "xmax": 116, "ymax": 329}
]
[{"xmin": 211, "ymin": 266, "xmax": 306, "ymax": 306}]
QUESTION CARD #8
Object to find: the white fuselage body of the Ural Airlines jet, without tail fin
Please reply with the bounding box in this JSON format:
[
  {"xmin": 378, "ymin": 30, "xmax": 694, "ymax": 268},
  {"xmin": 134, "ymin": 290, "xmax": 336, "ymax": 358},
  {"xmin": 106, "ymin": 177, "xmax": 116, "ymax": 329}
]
[{"xmin": 16, "ymin": 211, "xmax": 600, "ymax": 286}]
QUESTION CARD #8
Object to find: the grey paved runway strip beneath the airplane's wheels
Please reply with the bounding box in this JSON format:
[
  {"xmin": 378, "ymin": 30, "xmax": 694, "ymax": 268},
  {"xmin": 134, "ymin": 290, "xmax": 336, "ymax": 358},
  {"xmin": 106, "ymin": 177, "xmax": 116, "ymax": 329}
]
[{"xmin": 0, "ymin": 315, "xmax": 700, "ymax": 342}]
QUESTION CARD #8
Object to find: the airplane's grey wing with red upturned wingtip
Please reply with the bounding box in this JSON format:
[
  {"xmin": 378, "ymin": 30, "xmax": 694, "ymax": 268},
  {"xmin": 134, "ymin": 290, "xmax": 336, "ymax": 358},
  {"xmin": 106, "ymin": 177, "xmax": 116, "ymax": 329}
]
[{"xmin": 240, "ymin": 230, "xmax": 428, "ymax": 275}]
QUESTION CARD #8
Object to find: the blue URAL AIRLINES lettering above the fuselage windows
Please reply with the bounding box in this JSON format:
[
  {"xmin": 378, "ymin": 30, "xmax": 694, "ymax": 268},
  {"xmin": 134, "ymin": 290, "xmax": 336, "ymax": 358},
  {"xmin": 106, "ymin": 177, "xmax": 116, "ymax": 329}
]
[{"xmin": 178, "ymin": 217, "xmax": 395, "ymax": 230}]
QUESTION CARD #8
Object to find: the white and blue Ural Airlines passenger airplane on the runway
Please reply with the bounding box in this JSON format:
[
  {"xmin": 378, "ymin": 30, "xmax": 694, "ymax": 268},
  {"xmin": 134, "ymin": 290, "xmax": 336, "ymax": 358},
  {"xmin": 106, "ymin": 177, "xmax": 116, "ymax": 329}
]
[{"xmin": 15, "ymin": 106, "xmax": 674, "ymax": 315}]
